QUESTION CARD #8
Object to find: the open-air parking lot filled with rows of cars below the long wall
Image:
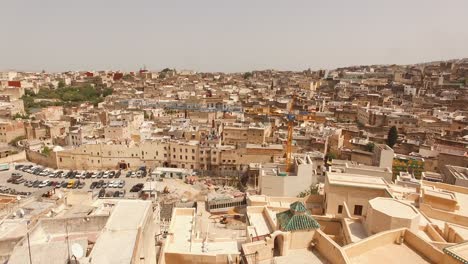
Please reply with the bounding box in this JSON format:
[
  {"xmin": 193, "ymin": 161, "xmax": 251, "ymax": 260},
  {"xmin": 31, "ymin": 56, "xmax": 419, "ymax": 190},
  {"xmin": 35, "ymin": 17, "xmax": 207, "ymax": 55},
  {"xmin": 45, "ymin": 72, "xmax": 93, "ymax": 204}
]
[{"xmin": 0, "ymin": 163, "xmax": 157, "ymax": 197}]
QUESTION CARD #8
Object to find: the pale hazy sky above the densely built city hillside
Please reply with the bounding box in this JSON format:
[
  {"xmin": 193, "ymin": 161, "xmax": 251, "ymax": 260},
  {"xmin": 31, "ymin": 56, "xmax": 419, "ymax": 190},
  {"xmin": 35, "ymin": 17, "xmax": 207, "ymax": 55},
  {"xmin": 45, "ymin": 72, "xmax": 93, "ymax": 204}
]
[{"xmin": 0, "ymin": 0, "xmax": 468, "ymax": 72}]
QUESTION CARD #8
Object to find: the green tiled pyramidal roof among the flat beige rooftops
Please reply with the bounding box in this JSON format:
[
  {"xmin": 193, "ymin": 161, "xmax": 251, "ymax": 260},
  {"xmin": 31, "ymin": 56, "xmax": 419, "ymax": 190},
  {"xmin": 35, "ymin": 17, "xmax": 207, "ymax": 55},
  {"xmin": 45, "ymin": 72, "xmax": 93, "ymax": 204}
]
[{"xmin": 276, "ymin": 202, "xmax": 320, "ymax": 231}]
